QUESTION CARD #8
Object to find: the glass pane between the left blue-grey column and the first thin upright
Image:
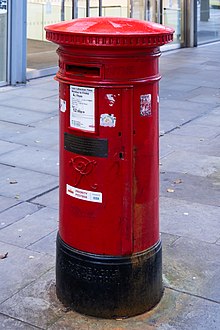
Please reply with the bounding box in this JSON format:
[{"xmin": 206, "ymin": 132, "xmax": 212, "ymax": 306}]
[{"xmin": 27, "ymin": 0, "xmax": 73, "ymax": 79}]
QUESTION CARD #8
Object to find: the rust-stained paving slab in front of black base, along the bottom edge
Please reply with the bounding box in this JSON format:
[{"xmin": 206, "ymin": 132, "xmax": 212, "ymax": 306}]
[{"xmin": 48, "ymin": 289, "xmax": 220, "ymax": 330}]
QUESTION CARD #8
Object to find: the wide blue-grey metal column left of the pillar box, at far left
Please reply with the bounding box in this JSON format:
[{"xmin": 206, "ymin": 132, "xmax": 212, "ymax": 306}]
[{"xmin": 9, "ymin": 0, "xmax": 27, "ymax": 85}]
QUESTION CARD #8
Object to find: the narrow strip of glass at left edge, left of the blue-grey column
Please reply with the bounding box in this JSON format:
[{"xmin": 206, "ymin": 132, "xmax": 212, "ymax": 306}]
[{"xmin": 0, "ymin": 0, "xmax": 8, "ymax": 86}]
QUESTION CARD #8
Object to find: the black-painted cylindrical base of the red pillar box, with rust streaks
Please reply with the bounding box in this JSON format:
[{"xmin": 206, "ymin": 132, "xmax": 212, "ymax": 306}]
[{"xmin": 56, "ymin": 234, "xmax": 163, "ymax": 318}]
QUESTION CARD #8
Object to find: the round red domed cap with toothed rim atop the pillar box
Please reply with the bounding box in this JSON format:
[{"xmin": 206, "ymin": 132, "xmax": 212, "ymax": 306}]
[{"xmin": 45, "ymin": 17, "xmax": 174, "ymax": 48}]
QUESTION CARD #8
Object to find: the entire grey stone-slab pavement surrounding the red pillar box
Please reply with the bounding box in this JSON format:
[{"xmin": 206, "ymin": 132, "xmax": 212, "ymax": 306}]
[{"xmin": 0, "ymin": 43, "xmax": 220, "ymax": 330}]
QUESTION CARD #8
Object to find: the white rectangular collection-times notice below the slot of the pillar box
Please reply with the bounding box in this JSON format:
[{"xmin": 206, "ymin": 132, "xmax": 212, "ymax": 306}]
[{"xmin": 70, "ymin": 85, "xmax": 95, "ymax": 132}]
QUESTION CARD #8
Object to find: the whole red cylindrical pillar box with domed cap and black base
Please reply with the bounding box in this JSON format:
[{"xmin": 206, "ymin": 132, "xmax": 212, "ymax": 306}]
[{"xmin": 45, "ymin": 17, "xmax": 174, "ymax": 318}]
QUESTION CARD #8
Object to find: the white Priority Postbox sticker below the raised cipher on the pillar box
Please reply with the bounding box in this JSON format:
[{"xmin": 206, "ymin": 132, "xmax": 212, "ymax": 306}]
[{"xmin": 66, "ymin": 184, "xmax": 102, "ymax": 203}]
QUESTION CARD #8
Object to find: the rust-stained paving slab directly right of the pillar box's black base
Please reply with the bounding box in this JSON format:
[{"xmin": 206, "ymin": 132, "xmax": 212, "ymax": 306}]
[{"xmin": 163, "ymin": 237, "xmax": 220, "ymax": 307}]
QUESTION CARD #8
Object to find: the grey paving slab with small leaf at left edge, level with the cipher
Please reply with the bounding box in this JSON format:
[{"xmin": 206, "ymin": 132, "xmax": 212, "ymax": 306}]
[{"xmin": 0, "ymin": 164, "xmax": 58, "ymax": 203}]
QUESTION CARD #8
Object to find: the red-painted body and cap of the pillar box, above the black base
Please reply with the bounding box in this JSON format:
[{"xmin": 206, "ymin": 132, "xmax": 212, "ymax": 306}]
[{"xmin": 46, "ymin": 18, "xmax": 173, "ymax": 256}]
